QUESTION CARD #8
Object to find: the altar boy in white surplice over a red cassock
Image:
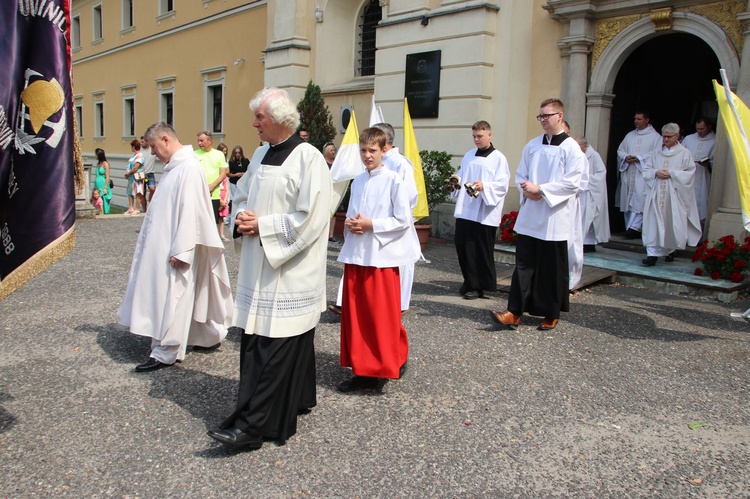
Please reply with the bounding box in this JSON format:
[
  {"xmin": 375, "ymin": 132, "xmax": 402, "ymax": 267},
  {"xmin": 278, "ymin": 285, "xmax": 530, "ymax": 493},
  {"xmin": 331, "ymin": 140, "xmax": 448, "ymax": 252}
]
[{"xmin": 338, "ymin": 128, "xmax": 419, "ymax": 392}]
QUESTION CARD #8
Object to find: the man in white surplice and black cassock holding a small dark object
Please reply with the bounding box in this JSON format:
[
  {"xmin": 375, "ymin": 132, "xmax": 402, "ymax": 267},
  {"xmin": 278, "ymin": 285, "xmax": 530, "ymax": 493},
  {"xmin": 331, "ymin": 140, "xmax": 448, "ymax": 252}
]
[{"xmin": 451, "ymin": 120, "xmax": 510, "ymax": 300}]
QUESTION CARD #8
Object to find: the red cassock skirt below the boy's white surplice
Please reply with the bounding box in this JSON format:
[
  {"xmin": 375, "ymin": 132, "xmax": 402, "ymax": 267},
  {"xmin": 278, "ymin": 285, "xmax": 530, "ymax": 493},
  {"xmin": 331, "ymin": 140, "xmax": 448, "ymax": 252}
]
[{"xmin": 341, "ymin": 264, "xmax": 409, "ymax": 379}]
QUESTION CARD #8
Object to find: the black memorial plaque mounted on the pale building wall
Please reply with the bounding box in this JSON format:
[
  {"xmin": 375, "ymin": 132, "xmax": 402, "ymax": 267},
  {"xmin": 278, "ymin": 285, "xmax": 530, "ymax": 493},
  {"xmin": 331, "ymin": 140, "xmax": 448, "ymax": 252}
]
[{"xmin": 404, "ymin": 50, "xmax": 441, "ymax": 118}]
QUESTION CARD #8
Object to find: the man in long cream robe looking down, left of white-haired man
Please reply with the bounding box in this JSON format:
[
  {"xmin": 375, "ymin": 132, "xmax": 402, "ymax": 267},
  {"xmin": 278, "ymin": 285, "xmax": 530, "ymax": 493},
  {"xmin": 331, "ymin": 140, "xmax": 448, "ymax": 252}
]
[{"xmin": 118, "ymin": 122, "xmax": 232, "ymax": 372}]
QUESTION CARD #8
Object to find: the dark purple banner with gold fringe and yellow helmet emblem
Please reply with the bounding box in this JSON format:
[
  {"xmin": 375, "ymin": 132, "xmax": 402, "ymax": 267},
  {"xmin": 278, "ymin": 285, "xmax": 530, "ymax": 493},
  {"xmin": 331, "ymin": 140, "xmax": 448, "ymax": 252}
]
[{"xmin": 0, "ymin": 0, "xmax": 75, "ymax": 299}]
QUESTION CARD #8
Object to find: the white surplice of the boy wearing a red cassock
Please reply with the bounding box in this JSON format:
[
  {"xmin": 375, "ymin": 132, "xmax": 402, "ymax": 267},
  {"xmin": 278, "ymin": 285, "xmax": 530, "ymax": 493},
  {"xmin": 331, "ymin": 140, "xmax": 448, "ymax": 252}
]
[{"xmin": 338, "ymin": 167, "xmax": 419, "ymax": 268}]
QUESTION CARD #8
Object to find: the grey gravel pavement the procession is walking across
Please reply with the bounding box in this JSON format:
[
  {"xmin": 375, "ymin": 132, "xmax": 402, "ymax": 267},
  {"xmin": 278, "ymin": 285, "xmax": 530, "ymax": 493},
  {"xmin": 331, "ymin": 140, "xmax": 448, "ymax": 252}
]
[{"xmin": 0, "ymin": 217, "xmax": 750, "ymax": 498}]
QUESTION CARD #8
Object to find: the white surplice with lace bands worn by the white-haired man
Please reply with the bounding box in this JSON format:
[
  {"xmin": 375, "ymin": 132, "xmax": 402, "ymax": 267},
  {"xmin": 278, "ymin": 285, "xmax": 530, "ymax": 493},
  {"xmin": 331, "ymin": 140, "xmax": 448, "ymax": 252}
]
[{"xmin": 233, "ymin": 143, "xmax": 333, "ymax": 338}]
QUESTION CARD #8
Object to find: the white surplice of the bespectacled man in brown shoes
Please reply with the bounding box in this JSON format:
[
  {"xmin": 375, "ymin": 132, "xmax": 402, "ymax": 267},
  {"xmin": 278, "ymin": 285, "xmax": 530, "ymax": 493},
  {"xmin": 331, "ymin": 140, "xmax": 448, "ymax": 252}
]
[{"xmin": 514, "ymin": 135, "xmax": 586, "ymax": 241}]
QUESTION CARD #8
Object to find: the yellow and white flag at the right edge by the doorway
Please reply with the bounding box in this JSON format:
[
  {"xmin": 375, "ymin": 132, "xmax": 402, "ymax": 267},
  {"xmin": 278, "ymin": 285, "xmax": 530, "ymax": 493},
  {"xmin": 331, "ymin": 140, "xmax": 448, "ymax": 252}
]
[{"xmin": 713, "ymin": 69, "xmax": 750, "ymax": 231}]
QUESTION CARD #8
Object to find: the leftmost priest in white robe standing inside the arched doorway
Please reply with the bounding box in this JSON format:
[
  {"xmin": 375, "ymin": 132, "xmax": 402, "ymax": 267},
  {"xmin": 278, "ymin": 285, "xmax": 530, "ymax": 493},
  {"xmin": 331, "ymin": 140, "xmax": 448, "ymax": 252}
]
[{"xmin": 615, "ymin": 111, "xmax": 661, "ymax": 239}]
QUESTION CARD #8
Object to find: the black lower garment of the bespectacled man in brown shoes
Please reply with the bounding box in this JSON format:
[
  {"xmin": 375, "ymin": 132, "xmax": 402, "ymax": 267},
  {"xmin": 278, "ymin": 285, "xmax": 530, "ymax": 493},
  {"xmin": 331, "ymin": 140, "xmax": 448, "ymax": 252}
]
[{"xmin": 508, "ymin": 234, "xmax": 570, "ymax": 319}]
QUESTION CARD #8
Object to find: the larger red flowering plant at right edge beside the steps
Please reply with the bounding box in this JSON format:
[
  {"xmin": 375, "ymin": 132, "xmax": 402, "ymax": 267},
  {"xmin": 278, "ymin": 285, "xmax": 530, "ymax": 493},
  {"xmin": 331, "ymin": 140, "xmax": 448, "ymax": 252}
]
[{"xmin": 693, "ymin": 235, "xmax": 750, "ymax": 282}]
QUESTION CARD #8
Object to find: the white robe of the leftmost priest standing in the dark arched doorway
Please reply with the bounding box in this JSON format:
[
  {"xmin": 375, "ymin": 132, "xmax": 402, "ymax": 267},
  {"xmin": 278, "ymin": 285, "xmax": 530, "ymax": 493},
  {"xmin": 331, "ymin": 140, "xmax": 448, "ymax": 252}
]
[{"xmin": 615, "ymin": 125, "xmax": 662, "ymax": 213}]
